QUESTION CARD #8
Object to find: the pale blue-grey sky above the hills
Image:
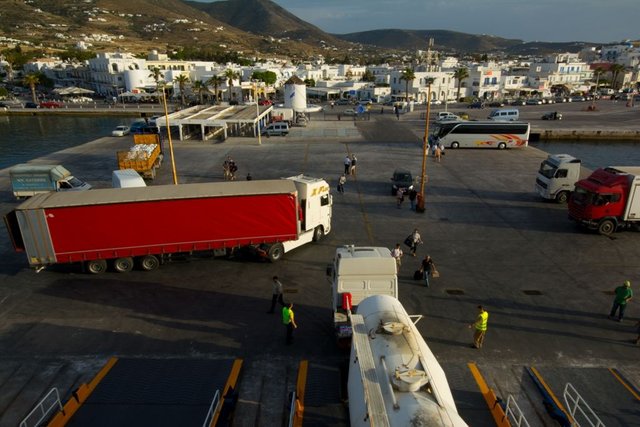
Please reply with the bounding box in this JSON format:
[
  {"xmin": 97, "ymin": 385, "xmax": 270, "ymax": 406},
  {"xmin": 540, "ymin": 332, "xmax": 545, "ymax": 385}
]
[{"xmin": 192, "ymin": 0, "xmax": 640, "ymax": 43}]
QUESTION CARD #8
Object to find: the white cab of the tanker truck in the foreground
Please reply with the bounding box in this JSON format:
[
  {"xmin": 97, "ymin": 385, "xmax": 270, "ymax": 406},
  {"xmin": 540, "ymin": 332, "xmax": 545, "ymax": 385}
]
[{"xmin": 327, "ymin": 245, "xmax": 398, "ymax": 347}]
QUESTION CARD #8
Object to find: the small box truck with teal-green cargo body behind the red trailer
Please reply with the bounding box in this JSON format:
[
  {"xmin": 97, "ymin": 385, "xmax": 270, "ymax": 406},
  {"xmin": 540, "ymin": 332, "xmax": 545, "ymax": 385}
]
[{"xmin": 9, "ymin": 163, "xmax": 91, "ymax": 199}]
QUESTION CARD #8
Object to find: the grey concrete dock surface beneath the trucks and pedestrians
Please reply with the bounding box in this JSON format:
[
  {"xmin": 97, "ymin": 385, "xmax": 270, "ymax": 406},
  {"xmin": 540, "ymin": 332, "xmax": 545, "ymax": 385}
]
[{"xmin": 0, "ymin": 103, "xmax": 640, "ymax": 427}]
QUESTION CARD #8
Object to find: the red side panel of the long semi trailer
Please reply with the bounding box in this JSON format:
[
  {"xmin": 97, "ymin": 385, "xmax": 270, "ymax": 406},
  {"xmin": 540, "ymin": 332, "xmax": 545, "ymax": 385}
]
[{"xmin": 45, "ymin": 194, "xmax": 298, "ymax": 262}]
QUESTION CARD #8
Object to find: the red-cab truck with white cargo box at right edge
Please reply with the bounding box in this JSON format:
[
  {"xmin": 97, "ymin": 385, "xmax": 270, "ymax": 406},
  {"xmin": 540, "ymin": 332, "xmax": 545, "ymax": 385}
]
[{"xmin": 569, "ymin": 166, "xmax": 640, "ymax": 236}]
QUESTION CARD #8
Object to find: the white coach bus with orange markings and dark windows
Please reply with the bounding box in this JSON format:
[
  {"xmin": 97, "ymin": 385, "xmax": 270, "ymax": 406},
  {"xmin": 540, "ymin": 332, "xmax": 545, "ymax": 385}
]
[{"xmin": 431, "ymin": 120, "xmax": 530, "ymax": 149}]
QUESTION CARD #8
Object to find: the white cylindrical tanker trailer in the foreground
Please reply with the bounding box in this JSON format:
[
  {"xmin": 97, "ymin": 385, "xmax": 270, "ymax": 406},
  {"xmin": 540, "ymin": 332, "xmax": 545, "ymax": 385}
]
[{"xmin": 347, "ymin": 295, "xmax": 467, "ymax": 427}]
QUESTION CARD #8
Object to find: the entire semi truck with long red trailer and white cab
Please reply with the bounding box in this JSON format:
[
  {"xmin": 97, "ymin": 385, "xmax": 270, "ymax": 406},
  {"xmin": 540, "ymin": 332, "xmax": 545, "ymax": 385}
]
[{"xmin": 5, "ymin": 175, "xmax": 332, "ymax": 274}]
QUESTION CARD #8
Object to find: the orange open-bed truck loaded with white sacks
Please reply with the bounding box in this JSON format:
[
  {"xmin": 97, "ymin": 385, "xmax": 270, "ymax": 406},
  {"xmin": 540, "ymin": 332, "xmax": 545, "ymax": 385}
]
[{"xmin": 116, "ymin": 133, "xmax": 163, "ymax": 179}]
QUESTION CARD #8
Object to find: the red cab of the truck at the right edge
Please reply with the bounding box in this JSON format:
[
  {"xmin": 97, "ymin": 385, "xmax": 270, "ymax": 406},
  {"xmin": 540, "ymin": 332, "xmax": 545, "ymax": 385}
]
[{"xmin": 569, "ymin": 168, "xmax": 634, "ymax": 235}]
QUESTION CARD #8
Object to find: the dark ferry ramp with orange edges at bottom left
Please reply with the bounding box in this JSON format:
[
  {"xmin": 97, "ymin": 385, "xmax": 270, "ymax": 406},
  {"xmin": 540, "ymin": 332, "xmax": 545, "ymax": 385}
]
[{"xmin": 44, "ymin": 358, "xmax": 242, "ymax": 427}]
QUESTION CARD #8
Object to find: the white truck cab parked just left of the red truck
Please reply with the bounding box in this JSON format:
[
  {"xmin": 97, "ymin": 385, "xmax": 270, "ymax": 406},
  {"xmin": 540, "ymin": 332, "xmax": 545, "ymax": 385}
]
[{"xmin": 536, "ymin": 154, "xmax": 584, "ymax": 203}]
